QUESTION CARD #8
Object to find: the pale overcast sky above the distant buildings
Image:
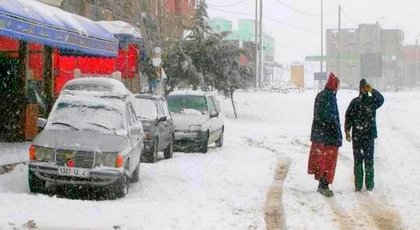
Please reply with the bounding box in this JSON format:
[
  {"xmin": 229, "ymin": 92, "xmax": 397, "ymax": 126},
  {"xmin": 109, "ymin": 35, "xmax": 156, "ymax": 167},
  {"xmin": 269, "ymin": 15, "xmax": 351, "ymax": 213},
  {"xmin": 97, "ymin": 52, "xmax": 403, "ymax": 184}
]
[{"xmin": 206, "ymin": 0, "xmax": 420, "ymax": 64}]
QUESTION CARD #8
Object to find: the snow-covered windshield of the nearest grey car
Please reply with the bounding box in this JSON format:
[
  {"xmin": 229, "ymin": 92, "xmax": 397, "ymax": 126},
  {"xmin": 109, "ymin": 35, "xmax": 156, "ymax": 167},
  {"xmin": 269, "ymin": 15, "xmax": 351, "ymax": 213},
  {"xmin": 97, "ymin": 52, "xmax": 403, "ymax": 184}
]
[{"xmin": 46, "ymin": 101, "xmax": 125, "ymax": 133}]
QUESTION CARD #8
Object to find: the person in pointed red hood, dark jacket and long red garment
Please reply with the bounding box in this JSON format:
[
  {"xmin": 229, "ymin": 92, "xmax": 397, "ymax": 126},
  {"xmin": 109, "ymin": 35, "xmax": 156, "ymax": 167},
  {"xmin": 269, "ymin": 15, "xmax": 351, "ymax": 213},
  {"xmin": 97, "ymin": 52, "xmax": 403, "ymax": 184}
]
[{"xmin": 308, "ymin": 73, "xmax": 343, "ymax": 197}]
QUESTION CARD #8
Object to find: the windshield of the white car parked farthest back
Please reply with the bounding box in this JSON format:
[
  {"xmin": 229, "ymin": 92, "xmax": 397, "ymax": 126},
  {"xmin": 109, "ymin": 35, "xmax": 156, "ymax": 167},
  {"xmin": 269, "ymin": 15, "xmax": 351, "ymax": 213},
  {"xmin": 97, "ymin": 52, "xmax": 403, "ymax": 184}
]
[{"xmin": 168, "ymin": 95, "xmax": 207, "ymax": 113}]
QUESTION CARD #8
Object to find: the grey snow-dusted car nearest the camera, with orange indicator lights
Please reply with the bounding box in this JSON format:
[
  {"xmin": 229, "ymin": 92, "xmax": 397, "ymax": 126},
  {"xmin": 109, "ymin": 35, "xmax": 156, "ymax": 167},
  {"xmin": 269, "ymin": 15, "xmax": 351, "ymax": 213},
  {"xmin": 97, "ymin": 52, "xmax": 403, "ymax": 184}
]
[{"xmin": 28, "ymin": 79, "xmax": 144, "ymax": 198}]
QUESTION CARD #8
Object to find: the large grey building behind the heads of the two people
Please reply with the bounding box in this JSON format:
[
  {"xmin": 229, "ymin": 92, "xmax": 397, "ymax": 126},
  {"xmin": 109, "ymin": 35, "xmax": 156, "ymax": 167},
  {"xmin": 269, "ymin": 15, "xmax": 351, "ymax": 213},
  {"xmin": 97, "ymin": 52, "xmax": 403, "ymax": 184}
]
[{"xmin": 325, "ymin": 24, "xmax": 404, "ymax": 90}]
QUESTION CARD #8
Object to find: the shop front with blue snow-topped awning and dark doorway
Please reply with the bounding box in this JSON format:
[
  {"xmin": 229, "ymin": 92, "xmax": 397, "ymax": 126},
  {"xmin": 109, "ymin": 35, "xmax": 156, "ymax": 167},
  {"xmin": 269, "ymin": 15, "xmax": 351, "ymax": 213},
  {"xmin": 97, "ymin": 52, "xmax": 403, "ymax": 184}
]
[{"xmin": 0, "ymin": 0, "xmax": 119, "ymax": 141}]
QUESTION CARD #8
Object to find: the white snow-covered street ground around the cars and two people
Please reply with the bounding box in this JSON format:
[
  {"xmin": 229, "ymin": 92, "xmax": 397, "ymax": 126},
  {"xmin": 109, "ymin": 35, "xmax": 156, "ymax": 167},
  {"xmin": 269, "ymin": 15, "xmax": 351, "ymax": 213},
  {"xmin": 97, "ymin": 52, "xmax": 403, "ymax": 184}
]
[{"xmin": 0, "ymin": 90, "xmax": 420, "ymax": 230}]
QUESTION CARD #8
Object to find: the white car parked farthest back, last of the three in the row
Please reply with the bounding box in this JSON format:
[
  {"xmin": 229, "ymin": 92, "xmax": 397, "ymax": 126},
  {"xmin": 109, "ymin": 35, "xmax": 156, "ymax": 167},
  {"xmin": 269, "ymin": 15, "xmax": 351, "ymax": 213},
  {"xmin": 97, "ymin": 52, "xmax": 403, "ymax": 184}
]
[{"xmin": 167, "ymin": 90, "xmax": 225, "ymax": 153}]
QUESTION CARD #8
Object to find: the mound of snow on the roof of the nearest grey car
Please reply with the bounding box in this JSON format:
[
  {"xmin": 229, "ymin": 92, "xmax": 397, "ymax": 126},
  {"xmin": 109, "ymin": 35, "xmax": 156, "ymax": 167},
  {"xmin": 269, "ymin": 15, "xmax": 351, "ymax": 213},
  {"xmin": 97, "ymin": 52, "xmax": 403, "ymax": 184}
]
[{"xmin": 61, "ymin": 77, "xmax": 131, "ymax": 95}]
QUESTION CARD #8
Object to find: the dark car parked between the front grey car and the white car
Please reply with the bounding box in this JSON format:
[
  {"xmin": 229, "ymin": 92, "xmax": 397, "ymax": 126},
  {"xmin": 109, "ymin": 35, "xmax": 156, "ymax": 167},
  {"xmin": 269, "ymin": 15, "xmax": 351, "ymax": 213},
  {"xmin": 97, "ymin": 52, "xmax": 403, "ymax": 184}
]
[{"xmin": 133, "ymin": 94, "xmax": 174, "ymax": 163}]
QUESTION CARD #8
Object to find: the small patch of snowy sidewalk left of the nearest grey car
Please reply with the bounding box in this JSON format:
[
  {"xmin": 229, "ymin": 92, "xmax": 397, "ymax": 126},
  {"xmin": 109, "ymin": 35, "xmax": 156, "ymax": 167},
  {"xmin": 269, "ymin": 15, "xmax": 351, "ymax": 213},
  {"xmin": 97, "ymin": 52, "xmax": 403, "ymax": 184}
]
[{"xmin": 0, "ymin": 142, "xmax": 31, "ymax": 174}]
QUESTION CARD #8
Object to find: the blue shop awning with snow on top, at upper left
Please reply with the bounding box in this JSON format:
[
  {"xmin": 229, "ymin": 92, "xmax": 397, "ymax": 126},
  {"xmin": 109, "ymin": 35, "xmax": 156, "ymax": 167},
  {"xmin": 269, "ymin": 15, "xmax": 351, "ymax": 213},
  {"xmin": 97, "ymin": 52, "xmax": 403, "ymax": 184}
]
[{"xmin": 0, "ymin": 0, "xmax": 118, "ymax": 57}]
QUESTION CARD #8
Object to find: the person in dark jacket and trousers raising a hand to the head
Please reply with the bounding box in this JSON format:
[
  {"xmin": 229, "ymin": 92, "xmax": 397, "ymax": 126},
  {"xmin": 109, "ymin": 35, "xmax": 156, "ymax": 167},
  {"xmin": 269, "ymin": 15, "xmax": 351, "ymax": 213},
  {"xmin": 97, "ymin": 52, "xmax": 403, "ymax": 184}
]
[{"xmin": 344, "ymin": 79, "xmax": 385, "ymax": 192}]
